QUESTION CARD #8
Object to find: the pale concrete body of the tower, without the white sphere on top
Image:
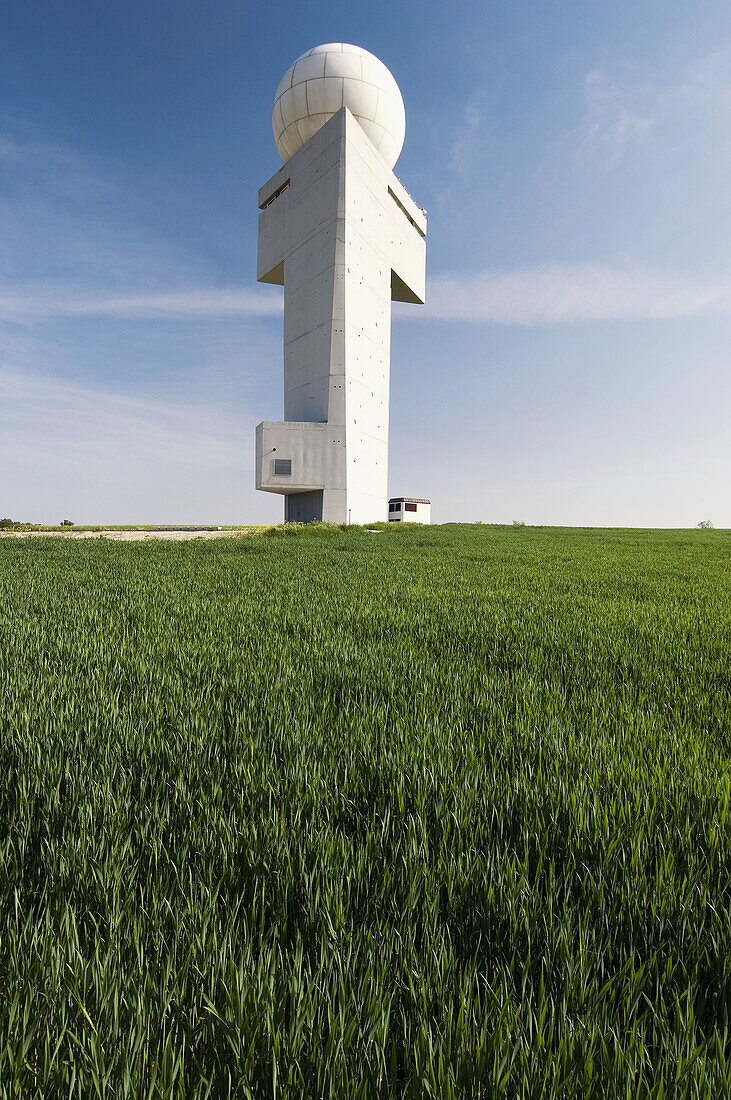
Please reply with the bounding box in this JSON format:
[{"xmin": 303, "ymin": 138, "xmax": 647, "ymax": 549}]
[{"xmin": 256, "ymin": 108, "xmax": 427, "ymax": 523}]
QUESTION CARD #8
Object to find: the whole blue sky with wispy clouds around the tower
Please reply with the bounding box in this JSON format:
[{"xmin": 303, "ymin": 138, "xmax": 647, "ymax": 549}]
[{"xmin": 0, "ymin": 0, "xmax": 731, "ymax": 527}]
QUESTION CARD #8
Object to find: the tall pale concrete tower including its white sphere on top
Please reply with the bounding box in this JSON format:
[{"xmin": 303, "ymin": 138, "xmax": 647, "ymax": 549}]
[{"xmin": 256, "ymin": 43, "xmax": 427, "ymax": 524}]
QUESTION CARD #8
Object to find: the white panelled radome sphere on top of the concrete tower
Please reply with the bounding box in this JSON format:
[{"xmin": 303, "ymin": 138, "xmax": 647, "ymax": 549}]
[{"xmin": 272, "ymin": 42, "xmax": 406, "ymax": 168}]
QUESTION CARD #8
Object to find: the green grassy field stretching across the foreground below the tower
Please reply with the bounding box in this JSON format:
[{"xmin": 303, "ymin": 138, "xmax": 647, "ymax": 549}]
[{"xmin": 0, "ymin": 525, "xmax": 731, "ymax": 1100}]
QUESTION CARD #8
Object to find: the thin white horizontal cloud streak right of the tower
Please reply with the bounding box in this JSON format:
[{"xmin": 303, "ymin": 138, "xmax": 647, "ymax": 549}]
[{"xmin": 419, "ymin": 264, "xmax": 731, "ymax": 325}]
